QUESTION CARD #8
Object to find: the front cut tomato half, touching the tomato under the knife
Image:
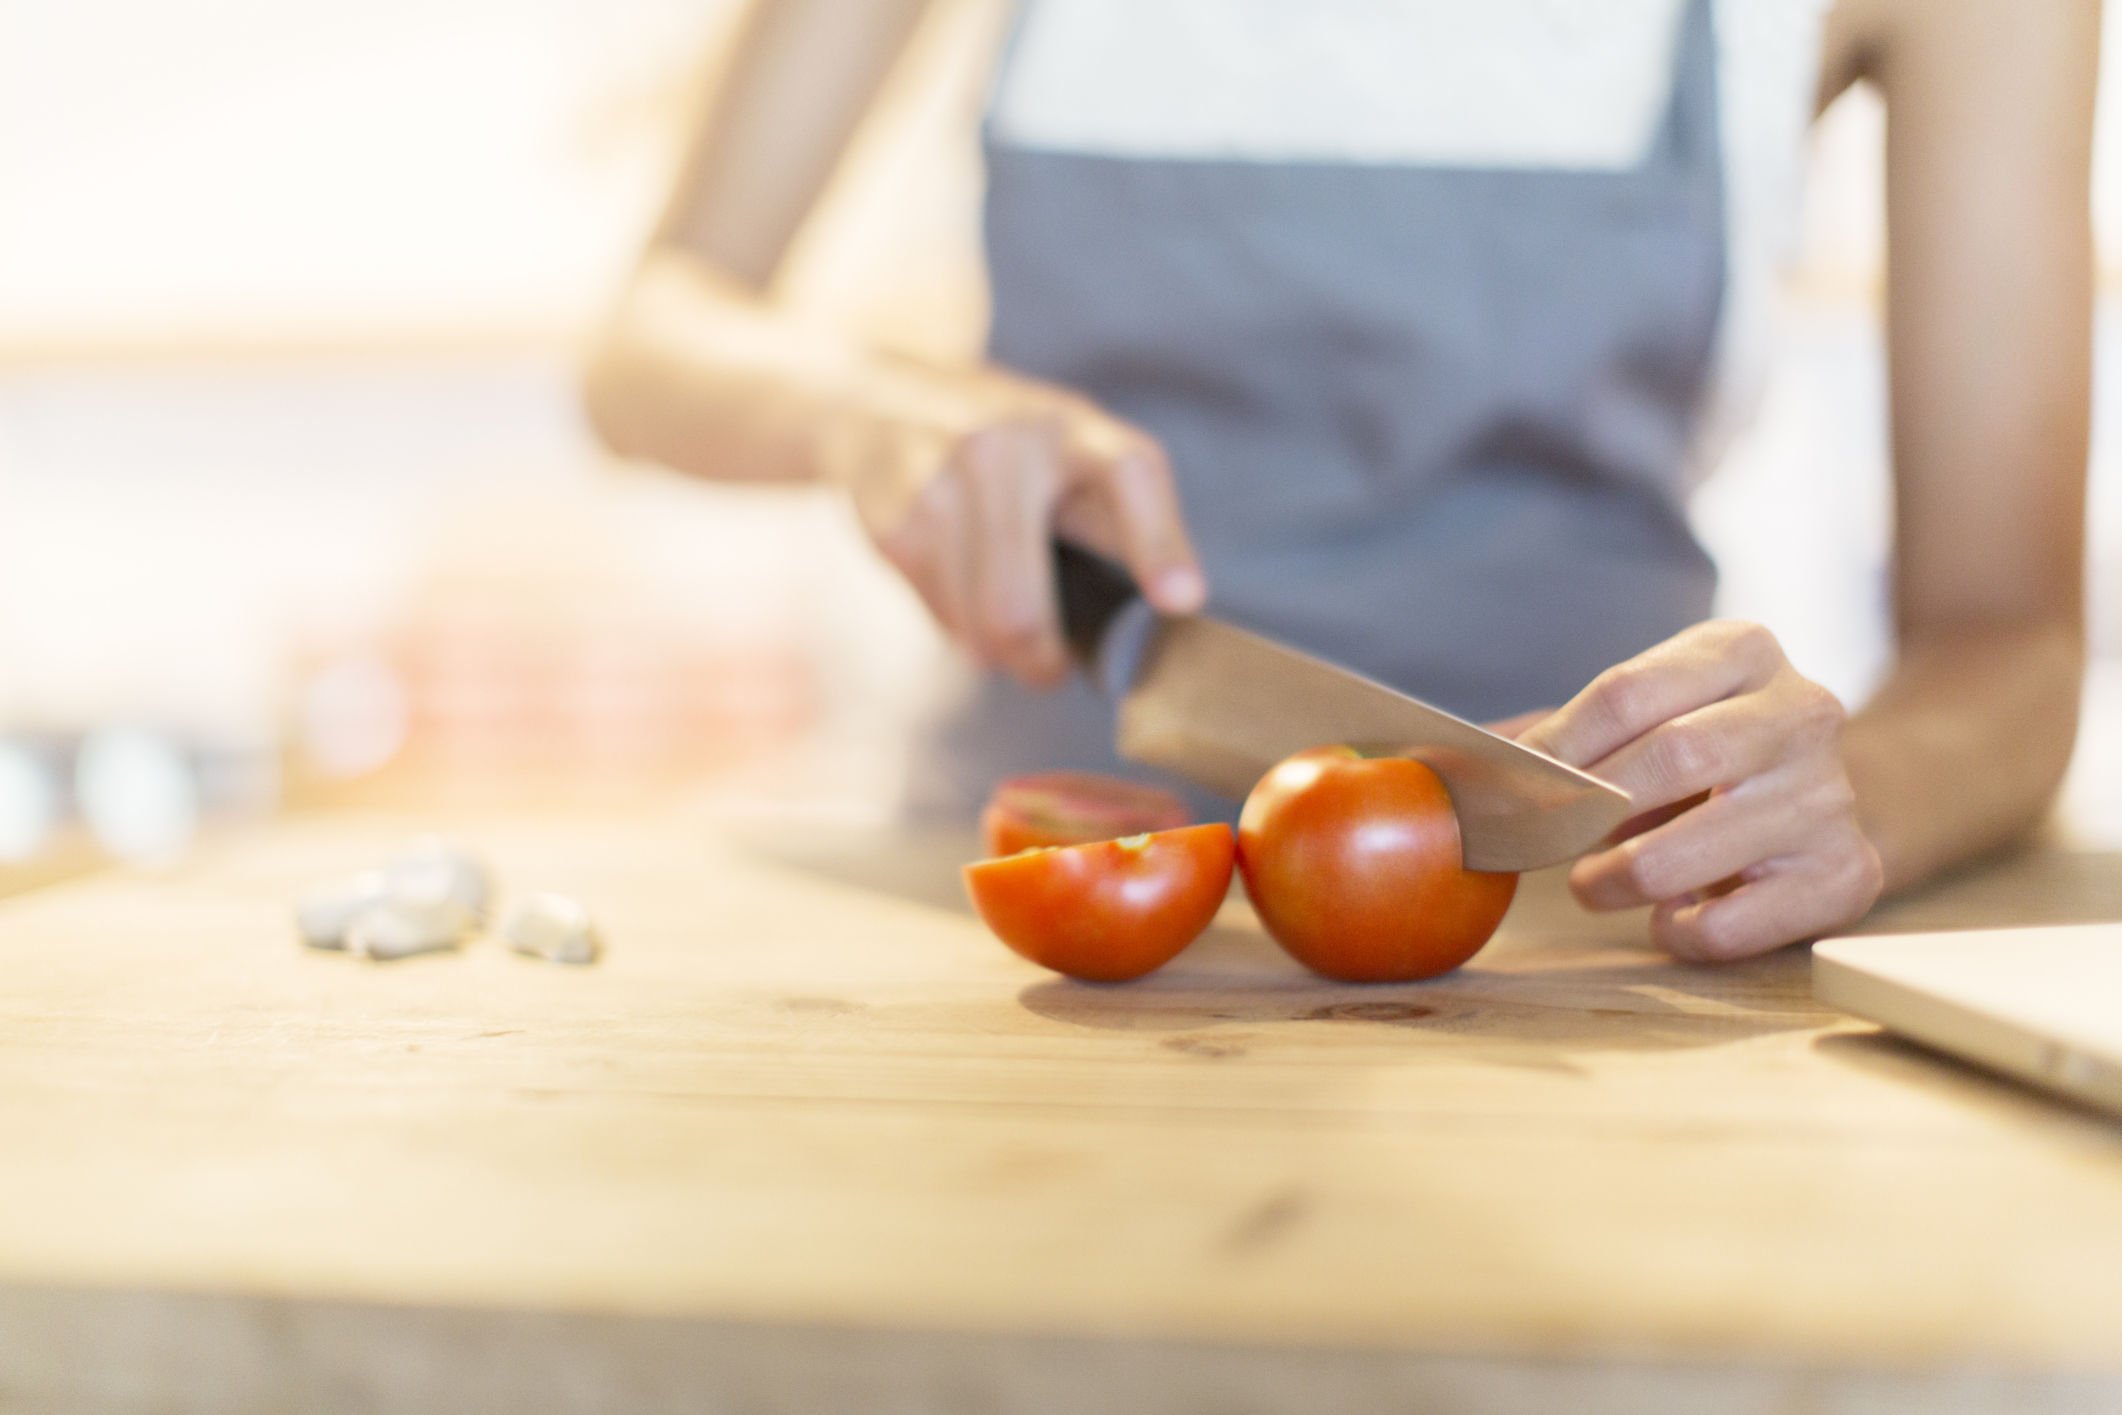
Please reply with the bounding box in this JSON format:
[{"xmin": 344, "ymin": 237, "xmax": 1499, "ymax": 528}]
[{"xmin": 966, "ymin": 823, "xmax": 1237, "ymax": 982}]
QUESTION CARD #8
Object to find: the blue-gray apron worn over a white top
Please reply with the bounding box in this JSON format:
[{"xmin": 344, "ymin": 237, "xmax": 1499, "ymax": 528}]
[{"xmin": 910, "ymin": 0, "xmax": 1725, "ymax": 815}]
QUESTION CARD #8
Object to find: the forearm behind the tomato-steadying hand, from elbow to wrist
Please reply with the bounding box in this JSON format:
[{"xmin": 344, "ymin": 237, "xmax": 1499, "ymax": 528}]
[{"xmin": 1844, "ymin": 619, "xmax": 2084, "ymax": 893}]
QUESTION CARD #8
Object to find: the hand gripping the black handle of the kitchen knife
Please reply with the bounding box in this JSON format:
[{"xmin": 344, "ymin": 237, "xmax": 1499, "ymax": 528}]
[{"xmin": 828, "ymin": 371, "xmax": 1207, "ymax": 685}]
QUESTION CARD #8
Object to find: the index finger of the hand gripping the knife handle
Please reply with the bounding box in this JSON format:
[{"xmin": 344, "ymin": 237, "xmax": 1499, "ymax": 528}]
[{"xmin": 1067, "ymin": 414, "xmax": 1207, "ymax": 613}]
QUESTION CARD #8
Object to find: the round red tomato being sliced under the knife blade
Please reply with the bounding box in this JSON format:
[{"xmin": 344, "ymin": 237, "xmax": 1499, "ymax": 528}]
[{"xmin": 1237, "ymin": 747, "xmax": 1517, "ymax": 982}]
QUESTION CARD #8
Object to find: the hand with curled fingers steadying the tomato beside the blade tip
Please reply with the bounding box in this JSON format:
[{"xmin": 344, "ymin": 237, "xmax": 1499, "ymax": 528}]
[{"xmin": 1511, "ymin": 619, "xmax": 1882, "ymax": 961}]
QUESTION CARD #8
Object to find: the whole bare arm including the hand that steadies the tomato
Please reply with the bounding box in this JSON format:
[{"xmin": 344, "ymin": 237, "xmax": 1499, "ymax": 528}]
[{"xmin": 1521, "ymin": 0, "xmax": 2099, "ymax": 959}]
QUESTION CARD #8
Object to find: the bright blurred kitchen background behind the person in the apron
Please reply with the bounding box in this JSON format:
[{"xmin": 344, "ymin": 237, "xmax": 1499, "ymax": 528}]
[{"xmin": 0, "ymin": 0, "xmax": 2122, "ymax": 889}]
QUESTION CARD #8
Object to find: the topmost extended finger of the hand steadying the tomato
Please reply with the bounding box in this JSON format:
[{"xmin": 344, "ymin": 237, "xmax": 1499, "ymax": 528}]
[{"xmin": 1521, "ymin": 619, "xmax": 1782, "ymax": 768}]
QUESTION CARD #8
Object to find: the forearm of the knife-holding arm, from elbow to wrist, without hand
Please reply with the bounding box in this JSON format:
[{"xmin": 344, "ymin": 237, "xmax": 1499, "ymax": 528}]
[{"xmin": 584, "ymin": 252, "xmax": 988, "ymax": 492}]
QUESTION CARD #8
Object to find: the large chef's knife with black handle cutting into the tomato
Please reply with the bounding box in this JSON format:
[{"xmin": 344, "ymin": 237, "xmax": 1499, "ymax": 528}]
[{"xmin": 1055, "ymin": 541, "xmax": 1632, "ymax": 870}]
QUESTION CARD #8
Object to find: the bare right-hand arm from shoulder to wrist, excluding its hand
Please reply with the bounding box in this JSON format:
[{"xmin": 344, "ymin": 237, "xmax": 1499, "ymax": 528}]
[{"xmin": 1842, "ymin": 0, "xmax": 2099, "ymax": 889}]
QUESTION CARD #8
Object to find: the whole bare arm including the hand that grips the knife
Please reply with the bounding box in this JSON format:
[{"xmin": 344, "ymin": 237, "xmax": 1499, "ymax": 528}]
[{"xmin": 586, "ymin": 0, "xmax": 1207, "ymax": 683}]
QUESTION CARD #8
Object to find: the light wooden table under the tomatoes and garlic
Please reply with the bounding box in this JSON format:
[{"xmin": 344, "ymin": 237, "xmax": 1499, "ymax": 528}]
[{"xmin": 0, "ymin": 815, "xmax": 2122, "ymax": 1415}]
